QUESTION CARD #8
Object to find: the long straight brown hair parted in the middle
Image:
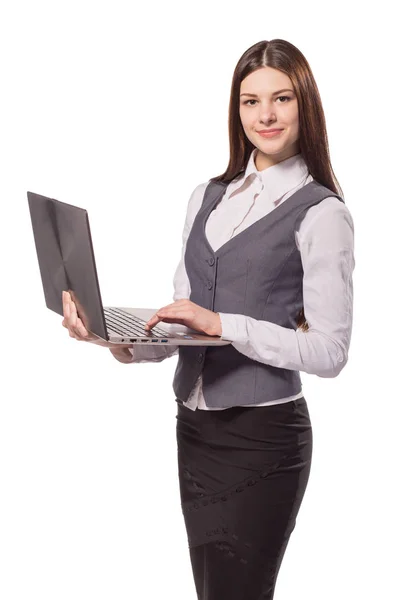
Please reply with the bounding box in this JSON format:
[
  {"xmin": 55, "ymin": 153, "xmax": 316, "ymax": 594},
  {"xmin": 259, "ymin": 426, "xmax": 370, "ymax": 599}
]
[{"xmin": 211, "ymin": 39, "xmax": 343, "ymax": 331}]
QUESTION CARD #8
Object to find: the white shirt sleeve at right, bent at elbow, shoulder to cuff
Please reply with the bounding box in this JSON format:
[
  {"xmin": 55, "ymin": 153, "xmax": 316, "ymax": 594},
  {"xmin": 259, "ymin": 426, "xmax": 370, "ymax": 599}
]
[{"xmin": 220, "ymin": 197, "xmax": 355, "ymax": 377}]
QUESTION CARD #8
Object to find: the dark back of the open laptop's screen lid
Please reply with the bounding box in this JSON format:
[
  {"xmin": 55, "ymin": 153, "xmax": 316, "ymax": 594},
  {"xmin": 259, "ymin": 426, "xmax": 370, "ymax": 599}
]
[{"xmin": 27, "ymin": 192, "xmax": 109, "ymax": 339}]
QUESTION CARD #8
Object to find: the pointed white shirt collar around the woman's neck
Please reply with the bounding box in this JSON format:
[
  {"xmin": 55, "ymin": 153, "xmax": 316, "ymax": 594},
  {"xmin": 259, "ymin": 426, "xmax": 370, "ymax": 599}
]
[{"xmin": 229, "ymin": 148, "xmax": 310, "ymax": 204}]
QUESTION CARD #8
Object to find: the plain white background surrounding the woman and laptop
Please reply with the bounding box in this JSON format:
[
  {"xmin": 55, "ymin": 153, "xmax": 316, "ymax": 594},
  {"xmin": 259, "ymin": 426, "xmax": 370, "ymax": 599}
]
[{"xmin": 0, "ymin": 0, "xmax": 400, "ymax": 600}]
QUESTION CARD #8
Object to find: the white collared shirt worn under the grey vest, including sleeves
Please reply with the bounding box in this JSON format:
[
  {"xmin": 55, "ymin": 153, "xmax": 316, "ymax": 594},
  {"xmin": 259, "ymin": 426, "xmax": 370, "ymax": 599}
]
[{"xmin": 126, "ymin": 149, "xmax": 355, "ymax": 410}]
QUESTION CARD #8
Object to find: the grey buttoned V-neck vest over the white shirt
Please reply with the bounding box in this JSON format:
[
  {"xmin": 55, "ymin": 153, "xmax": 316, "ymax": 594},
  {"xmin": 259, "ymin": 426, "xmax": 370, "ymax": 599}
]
[{"xmin": 172, "ymin": 180, "xmax": 344, "ymax": 408}]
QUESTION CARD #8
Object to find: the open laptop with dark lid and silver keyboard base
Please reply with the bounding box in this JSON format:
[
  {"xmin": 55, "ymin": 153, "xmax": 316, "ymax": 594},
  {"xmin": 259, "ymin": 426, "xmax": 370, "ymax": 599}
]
[{"xmin": 27, "ymin": 192, "xmax": 231, "ymax": 346}]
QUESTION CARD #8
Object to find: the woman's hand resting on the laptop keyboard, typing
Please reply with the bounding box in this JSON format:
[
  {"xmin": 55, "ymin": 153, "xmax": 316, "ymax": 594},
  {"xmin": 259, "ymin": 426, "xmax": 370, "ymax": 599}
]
[{"xmin": 145, "ymin": 298, "xmax": 222, "ymax": 336}]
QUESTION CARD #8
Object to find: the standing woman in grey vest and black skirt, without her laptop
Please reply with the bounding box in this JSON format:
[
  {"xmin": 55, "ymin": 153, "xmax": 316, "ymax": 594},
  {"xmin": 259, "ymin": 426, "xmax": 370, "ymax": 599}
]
[{"xmin": 63, "ymin": 39, "xmax": 355, "ymax": 600}]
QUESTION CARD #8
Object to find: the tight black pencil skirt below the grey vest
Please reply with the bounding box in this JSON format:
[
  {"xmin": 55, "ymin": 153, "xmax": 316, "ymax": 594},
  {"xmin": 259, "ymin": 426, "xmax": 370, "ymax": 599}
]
[{"xmin": 176, "ymin": 396, "xmax": 313, "ymax": 600}]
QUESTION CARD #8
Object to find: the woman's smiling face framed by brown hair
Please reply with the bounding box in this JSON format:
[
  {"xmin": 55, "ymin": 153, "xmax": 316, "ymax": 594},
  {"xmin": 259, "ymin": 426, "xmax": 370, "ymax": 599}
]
[{"xmin": 239, "ymin": 67, "xmax": 300, "ymax": 171}]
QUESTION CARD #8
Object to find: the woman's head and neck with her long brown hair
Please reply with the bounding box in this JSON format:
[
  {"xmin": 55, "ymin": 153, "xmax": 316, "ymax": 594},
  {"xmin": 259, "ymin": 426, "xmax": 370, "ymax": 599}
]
[{"xmin": 210, "ymin": 39, "xmax": 342, "ymax": 195}]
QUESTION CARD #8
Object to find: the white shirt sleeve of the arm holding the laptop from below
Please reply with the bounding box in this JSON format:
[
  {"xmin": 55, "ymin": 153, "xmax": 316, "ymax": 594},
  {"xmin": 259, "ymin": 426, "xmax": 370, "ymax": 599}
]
[{"xmin": 129, "ymin": 181, "xmax": 208, "ymax": 363}]
